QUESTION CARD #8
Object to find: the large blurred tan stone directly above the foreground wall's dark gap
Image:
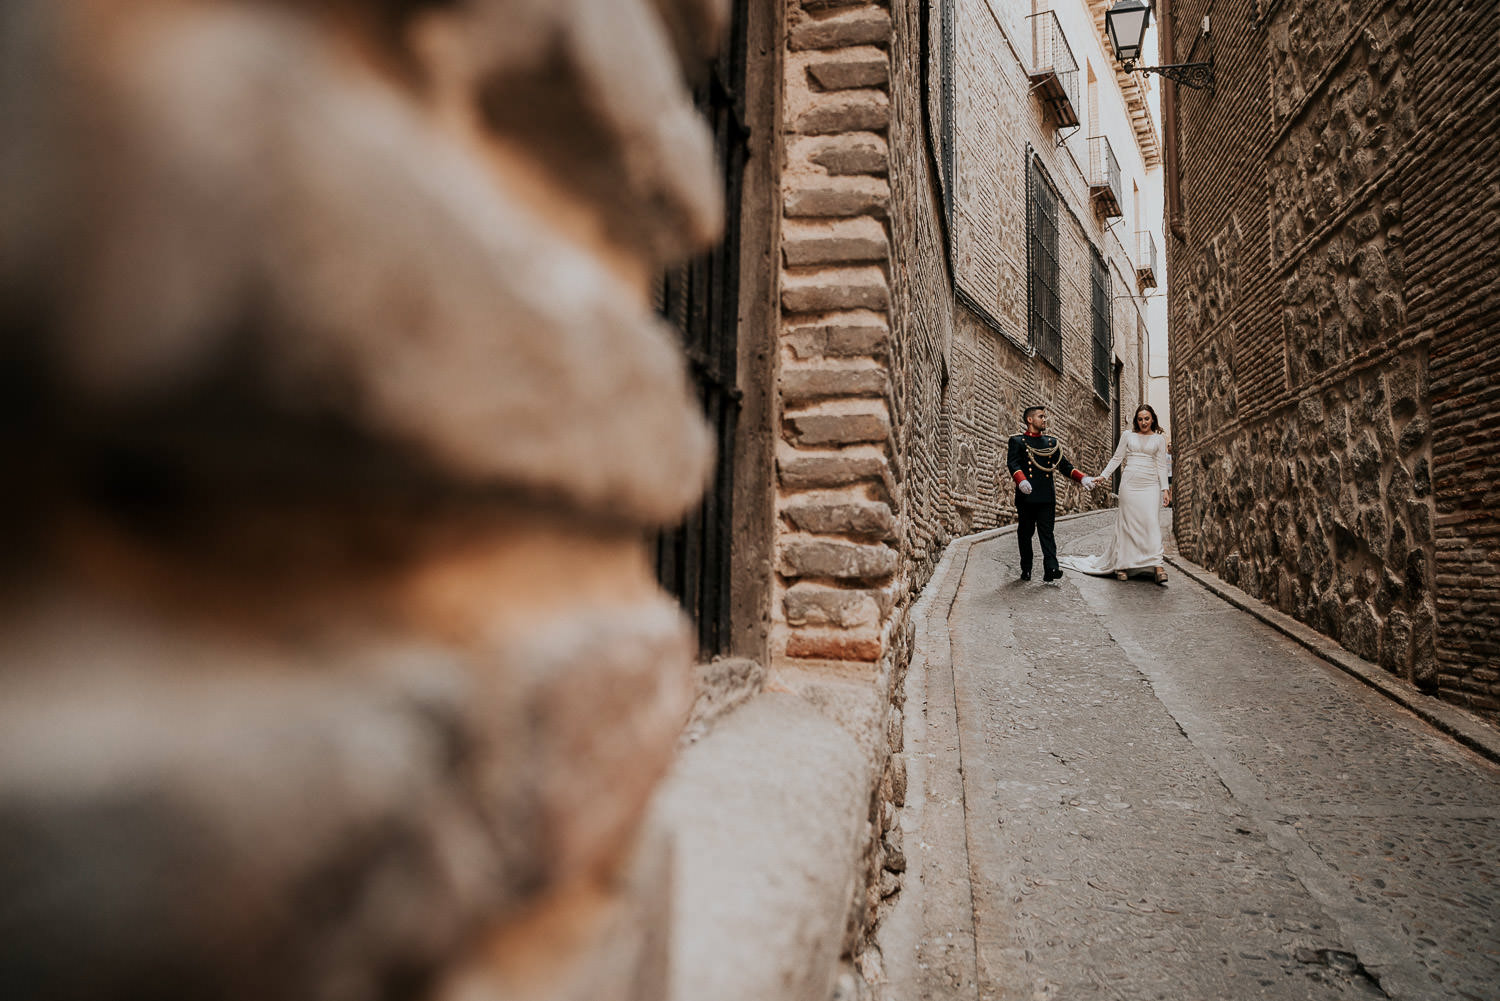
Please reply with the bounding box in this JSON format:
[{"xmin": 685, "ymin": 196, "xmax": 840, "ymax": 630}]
[{"xmin": 8, "ymin": 5, "xmax": 713, "ymax": 524}]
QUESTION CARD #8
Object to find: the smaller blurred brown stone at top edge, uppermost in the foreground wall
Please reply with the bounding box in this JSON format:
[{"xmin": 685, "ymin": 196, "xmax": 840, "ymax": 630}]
[{"xmin": 447, "ymin": 0, "xmax": 723, "ymax": 260}]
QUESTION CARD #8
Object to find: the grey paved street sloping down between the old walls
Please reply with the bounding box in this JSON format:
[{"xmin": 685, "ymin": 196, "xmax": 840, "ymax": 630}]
[{"xmin": 885, "ymin": 515, "xmax": 1500, "ymax": 1001}]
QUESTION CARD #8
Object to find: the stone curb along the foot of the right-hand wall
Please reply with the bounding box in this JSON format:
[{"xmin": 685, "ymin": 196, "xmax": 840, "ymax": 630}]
[{"xmin": 1167, "ymin": 554, "xmax": 1500, "ymax": 764}]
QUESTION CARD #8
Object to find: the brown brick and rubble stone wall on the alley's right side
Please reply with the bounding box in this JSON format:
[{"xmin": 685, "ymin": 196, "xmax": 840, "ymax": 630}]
[{"xmin": 1170, "ymin": 0, "xmax": 1500, "ymax": 713}]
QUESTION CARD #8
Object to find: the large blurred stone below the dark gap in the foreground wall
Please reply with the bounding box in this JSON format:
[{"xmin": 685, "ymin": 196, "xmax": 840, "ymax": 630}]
[{"xmin": 0, "ymin": 579, "xmax": 689, "ymax": 1001}]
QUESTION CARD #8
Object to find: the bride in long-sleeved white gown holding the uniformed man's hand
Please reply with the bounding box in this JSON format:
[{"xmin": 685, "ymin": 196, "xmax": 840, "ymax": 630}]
[{"xmin": 1061, "ymin": 404, "xmax": 1172, "ymax": 584}]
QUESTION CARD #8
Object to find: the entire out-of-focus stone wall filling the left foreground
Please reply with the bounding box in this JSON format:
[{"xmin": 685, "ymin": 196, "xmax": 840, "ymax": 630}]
[{"xmin": 0, "ymin": 0, "xmax": 723, "ymax": 1001}]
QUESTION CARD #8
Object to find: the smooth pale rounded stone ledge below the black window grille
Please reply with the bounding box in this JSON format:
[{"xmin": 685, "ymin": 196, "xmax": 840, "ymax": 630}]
[{"xmin": 656, "ymin": 693, "xmax": 870, "ymax": 1001}]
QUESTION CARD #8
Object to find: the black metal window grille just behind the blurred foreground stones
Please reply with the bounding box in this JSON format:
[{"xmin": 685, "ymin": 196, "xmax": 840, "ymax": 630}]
[{"xmin": 656, "ymin": 0, "xmax": 749, "ymax": 659}]
